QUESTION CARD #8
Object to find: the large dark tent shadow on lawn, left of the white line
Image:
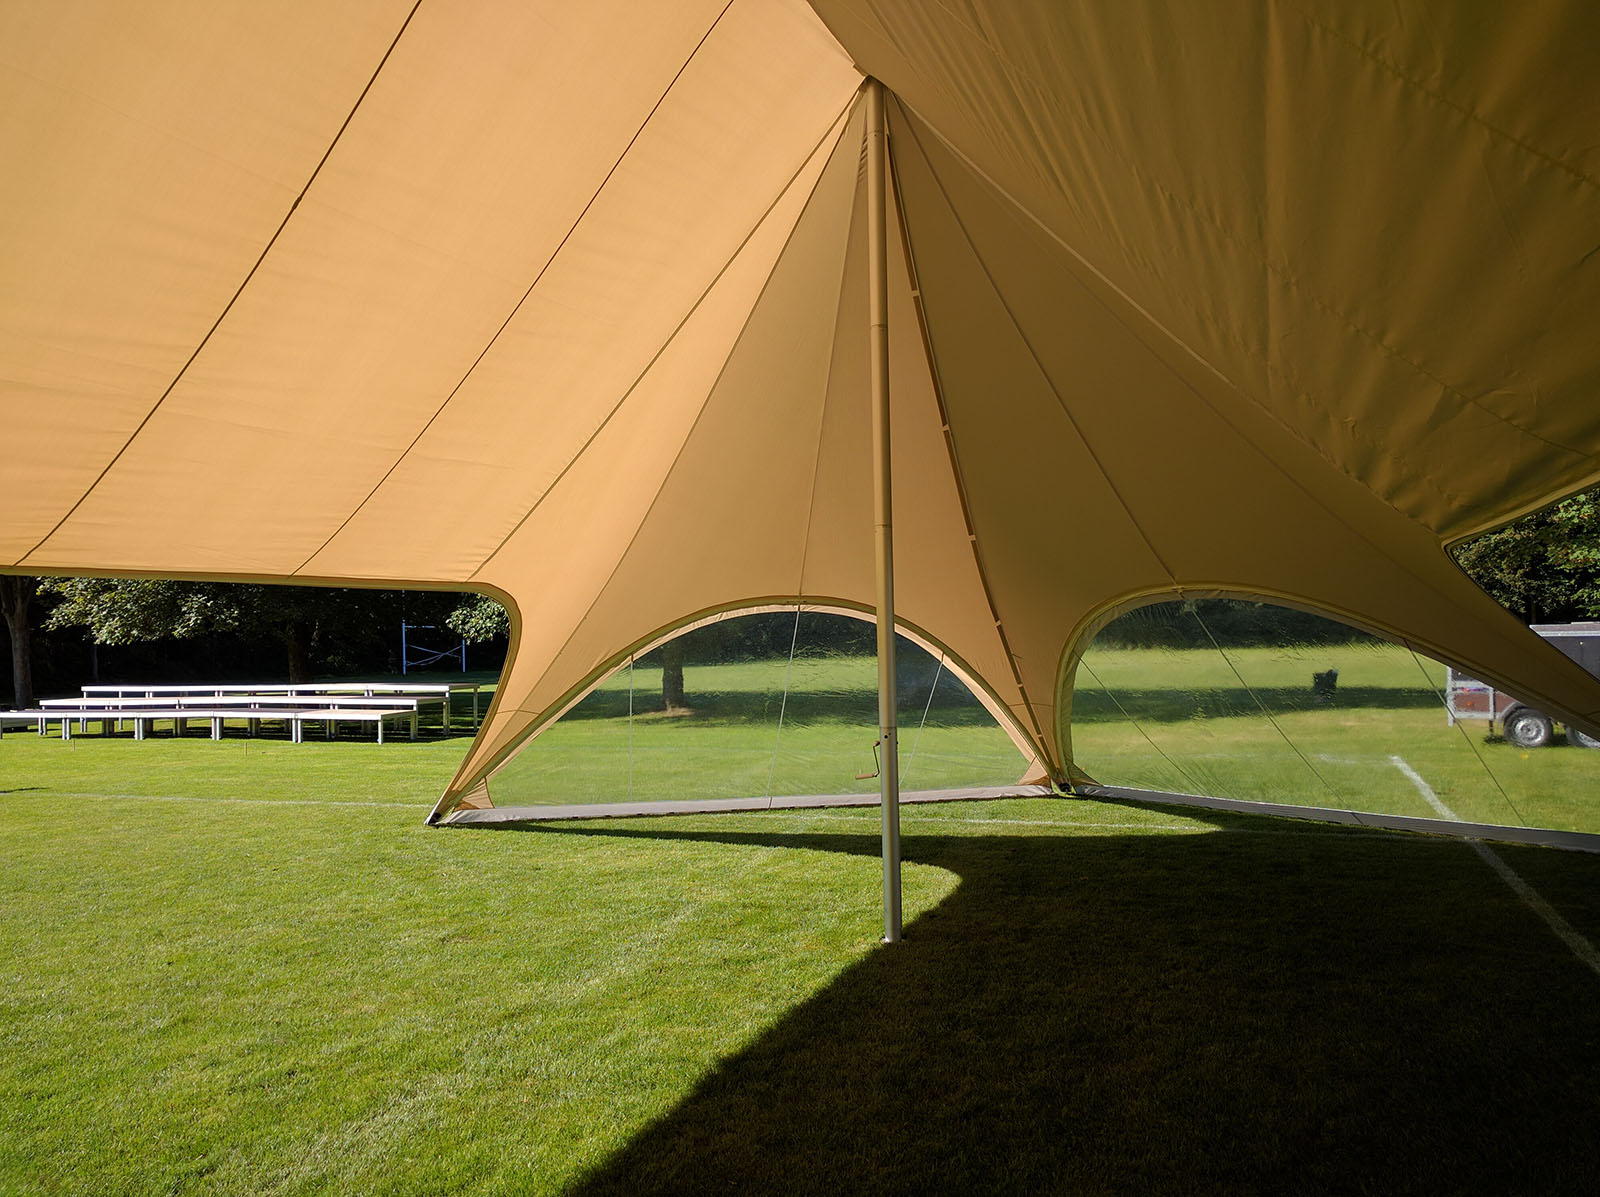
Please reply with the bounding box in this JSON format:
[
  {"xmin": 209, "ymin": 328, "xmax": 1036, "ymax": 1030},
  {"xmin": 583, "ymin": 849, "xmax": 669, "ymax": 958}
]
[{"xmin": 515, "ymin": 815, "xmax": 1600, "ymax": 1194}]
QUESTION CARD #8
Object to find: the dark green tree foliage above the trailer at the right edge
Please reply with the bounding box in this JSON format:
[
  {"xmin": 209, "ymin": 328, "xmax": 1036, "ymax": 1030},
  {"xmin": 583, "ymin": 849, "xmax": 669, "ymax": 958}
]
[{"xmin": 1453, "ymin": 490, "xmax": 1600, "ymax": 624}]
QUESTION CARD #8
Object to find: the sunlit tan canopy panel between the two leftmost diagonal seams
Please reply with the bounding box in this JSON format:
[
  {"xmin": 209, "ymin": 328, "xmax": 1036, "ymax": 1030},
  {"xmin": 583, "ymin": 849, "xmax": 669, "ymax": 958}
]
[{"xmin": 21, "ymin": 6, "xmax": 732, "ymax": 576}]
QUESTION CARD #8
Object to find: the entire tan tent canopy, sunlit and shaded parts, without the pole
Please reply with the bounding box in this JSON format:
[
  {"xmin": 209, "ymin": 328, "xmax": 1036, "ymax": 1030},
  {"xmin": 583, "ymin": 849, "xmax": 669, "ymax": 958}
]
[{"xmin": 0, "ymin": 0, "xmax": 1600, "ymax": 815}]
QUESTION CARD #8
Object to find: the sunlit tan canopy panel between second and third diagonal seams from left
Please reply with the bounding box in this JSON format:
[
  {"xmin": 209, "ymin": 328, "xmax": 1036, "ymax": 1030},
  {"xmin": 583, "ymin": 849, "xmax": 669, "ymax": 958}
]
[{"xmin": 307, "ymin": 0, "xmax": 859, "ymax": 576}]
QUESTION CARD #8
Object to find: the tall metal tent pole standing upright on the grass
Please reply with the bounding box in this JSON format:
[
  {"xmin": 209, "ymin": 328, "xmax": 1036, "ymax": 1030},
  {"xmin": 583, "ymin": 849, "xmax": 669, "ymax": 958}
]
[{"xmin": 867, "ymin": 78, "xmax": 901, "ymax": 944}]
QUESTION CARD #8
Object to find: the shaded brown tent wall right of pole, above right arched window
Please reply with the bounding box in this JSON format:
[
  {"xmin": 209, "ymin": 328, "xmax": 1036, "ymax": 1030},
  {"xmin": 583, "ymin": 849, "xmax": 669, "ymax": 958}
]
[{"xmin": 898, "ymin": 98, "xmax": 1600, "ymax": 762}]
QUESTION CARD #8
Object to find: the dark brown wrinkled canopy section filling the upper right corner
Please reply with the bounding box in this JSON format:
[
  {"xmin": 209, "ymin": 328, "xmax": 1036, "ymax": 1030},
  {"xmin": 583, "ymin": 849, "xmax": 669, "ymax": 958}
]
[{"xmin": 818, "ymin": 0, "xmax": 1600, "ymax": 538}]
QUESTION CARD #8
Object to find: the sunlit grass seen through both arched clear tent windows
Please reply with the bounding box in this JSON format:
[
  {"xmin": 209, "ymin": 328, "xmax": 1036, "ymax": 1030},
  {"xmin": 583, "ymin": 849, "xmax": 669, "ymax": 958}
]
[{"xmin": 491, "ymin": 645, "xmax": 1600, "ymax": 831}]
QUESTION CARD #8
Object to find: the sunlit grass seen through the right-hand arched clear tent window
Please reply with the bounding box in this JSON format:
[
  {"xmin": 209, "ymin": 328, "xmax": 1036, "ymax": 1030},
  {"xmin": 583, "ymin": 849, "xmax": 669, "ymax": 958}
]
[{"xmin": 1074, "ymin": 645, "xmax": 1600, "ymax": 831}]
